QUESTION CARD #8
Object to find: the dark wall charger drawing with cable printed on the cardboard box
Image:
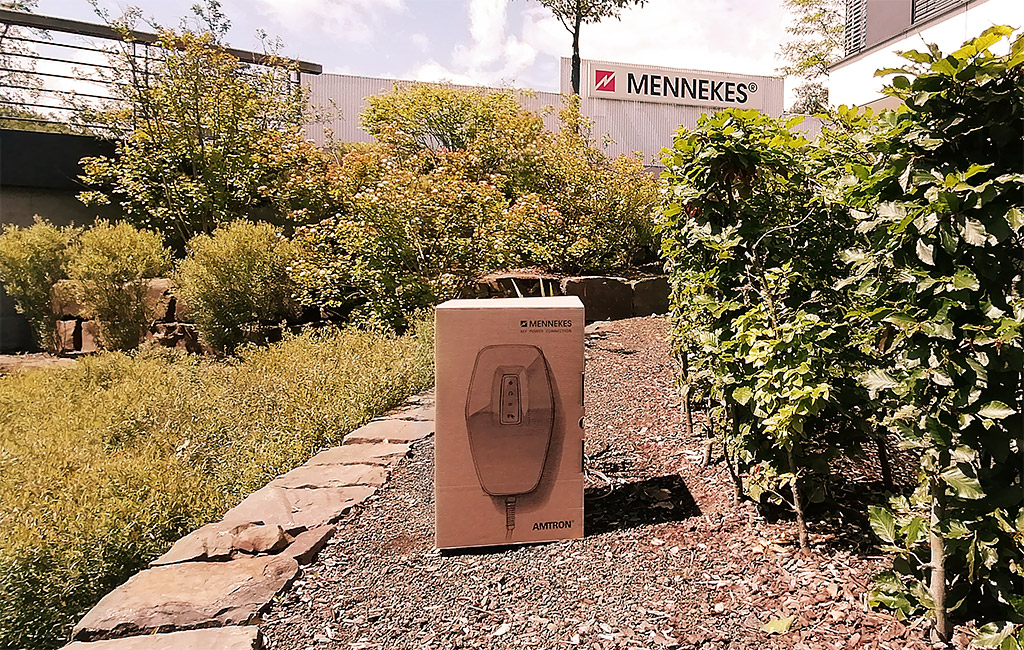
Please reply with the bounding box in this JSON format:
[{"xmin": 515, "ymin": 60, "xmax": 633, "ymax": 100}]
[{"xmin": 466, "ymin": 345, "xmax": 555, "ymax": 538}]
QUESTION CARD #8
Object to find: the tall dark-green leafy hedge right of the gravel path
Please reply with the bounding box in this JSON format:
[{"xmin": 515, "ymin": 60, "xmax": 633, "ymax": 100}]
[{"xmin": 663, "ymin": 26, "xmax": 1024, "ymax": 648}]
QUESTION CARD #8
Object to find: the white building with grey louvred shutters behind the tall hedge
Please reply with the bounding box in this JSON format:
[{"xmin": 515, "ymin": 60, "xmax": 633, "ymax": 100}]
[{"xmin": 828, "ymin": 0, "xmax": 1024, "ymax": 107}]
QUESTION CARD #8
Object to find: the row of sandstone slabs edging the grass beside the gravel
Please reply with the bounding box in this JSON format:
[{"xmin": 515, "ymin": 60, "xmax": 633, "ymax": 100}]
[{"xmin": 63, "ymin": 389, "xmax": 434, "ymax": 650}]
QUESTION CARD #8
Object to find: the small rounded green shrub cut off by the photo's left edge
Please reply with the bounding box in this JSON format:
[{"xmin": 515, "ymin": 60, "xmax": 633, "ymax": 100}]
[{"xmin": 0, "ymin": 217, "xmax": 81, "ymax": 352}]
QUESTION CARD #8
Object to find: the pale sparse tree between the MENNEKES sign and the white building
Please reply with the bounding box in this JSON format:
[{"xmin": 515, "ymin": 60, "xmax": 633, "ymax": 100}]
[{"xmin": 776, "ymin": 0, "xmax": 845, "ymax": 113}]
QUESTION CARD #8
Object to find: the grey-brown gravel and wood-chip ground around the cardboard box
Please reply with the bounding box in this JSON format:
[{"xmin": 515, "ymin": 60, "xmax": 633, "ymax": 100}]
[{"xmin": 262, "ymin": 317, "xmax": 963, "ymax": 650}]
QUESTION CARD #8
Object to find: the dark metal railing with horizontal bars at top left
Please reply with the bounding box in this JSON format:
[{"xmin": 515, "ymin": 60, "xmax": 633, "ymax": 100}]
[{"xmin": 0, "ymin": 9, "xmax": 323, "ymax": 132}]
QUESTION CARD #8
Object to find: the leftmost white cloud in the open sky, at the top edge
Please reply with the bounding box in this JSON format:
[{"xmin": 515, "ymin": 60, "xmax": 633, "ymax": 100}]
[{"xmin": 250, "ymin": 0, "xmax": 406, "ymax": 43}]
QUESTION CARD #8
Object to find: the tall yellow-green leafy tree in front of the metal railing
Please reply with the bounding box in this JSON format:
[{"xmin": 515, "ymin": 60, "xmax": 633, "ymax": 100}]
[{"xmin": 79, "ymin": 12, "xmax": 311, "ymax": 250}]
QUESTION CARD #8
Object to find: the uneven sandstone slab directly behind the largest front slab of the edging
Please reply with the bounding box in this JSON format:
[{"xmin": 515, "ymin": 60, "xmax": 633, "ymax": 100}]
[{"xmin": 150, "ymin": 521, "xmax": 292, "ymax": 566}]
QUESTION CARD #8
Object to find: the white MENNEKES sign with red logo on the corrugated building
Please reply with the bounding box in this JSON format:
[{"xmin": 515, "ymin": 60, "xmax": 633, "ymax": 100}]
[{"xmin": 587, "ymin": 61, "xmax": 765, "ymax": 109}]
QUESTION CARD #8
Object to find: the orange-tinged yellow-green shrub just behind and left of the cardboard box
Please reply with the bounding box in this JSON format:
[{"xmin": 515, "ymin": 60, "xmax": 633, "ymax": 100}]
[{"xmin": 293, "ymin": 152, "xmax": 506, "ymax": 331}]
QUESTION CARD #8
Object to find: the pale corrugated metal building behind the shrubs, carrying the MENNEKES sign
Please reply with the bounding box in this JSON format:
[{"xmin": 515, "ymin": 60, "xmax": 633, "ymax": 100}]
[{"xmin": 303, "ymin": 58, "xmax": 783, "ymax": 165}]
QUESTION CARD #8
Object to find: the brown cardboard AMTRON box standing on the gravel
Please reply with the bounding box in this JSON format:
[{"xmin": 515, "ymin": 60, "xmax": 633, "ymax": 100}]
[{"xmin": 434, "ymin": 296, "xmax": 584, "ymax": 549}]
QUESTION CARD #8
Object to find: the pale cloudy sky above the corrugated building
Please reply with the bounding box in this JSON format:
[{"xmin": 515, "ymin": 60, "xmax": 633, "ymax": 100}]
[{"xmin": 36, "ymin": 0, "xmax": 790, "ymax": 103}]
